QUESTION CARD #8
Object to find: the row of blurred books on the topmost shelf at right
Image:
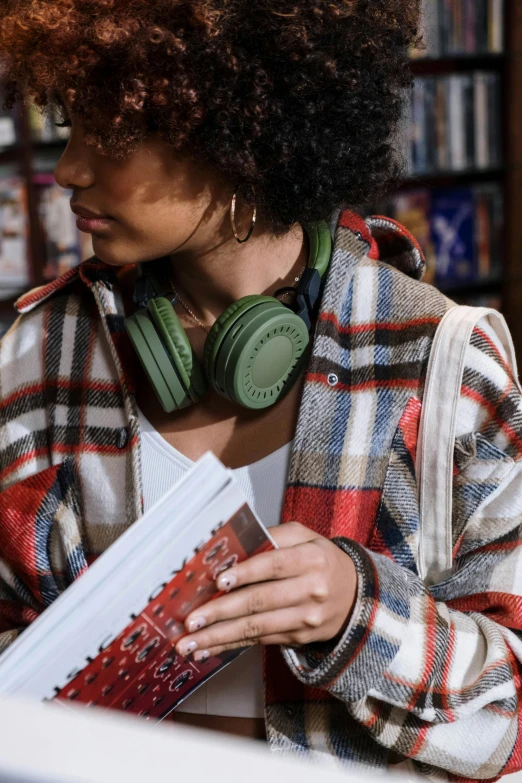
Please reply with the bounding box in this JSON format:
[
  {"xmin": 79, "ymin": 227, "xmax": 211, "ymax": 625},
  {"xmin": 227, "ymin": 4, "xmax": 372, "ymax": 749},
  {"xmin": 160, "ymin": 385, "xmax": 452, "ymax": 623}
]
[{"xmin": 412, "ymin": 0, "xmax": 502, "ymax": 59}]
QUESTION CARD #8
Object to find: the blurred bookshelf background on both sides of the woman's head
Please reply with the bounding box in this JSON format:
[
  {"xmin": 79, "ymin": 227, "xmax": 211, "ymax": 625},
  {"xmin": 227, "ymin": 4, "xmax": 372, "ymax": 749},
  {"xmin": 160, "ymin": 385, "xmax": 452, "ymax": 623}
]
[{"xmin": 0, "ymin": 0, "xmax": 522, "ymax": 359}]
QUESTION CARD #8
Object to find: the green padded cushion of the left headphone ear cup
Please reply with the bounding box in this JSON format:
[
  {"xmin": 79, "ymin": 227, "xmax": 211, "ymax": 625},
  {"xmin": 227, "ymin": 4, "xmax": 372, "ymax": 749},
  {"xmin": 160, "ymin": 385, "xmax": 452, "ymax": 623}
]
[{"xmin": 147, "ymin": 296, "xmax": 206, "ymax": 402}]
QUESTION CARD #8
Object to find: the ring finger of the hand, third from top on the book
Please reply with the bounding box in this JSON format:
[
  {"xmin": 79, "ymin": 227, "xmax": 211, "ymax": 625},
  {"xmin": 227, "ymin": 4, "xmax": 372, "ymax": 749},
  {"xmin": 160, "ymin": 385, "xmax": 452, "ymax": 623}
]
[{"xmin": 176, "ymin": 608, "xmax": 304, "ymax": 657}]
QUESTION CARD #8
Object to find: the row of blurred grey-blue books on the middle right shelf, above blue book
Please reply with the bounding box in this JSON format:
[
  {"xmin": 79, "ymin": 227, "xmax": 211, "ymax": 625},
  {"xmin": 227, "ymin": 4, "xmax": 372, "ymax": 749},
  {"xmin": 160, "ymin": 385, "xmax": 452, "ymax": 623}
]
[{"xmin": 406, "ymin": 71, "xmax": 502, "ymax": 175}]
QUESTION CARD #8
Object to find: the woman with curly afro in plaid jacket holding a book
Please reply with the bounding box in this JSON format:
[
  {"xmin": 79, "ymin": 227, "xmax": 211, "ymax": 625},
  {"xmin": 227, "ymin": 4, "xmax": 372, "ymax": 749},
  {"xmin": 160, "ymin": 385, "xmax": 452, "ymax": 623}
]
[{"xmin": 0, "ymin": 0, "xmax": 522, "ymax": 778}]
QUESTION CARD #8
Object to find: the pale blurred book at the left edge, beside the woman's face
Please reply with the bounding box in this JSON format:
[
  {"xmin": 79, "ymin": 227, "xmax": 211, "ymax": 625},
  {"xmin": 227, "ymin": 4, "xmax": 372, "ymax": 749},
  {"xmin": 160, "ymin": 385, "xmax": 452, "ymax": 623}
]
[{"xmin": 0, "ymin": 169, "xmax": 31, "ymax": 299}]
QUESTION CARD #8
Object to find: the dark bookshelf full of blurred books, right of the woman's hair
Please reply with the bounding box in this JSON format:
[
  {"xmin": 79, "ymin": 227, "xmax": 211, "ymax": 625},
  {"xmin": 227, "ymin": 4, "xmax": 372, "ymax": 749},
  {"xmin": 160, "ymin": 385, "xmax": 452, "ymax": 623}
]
[{"xmin": 380, "ymin": 0, "xmax": 512, "ymax": 332}]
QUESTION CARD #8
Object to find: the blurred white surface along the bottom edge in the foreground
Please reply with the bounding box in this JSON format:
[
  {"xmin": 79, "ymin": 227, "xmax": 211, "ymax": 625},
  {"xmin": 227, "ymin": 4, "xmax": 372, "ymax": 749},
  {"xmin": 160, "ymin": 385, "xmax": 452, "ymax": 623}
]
[{"xmin": 0, "ymin": 701, "xmax": 400, "ymax": 783}]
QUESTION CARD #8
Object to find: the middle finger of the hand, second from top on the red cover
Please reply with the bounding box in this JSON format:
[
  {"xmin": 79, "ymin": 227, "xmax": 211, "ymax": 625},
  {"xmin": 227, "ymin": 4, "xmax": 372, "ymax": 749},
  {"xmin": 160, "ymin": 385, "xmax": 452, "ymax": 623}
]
[{"xmin": 185, "ymin": 576, "xmax": 311, "ymax": 633}]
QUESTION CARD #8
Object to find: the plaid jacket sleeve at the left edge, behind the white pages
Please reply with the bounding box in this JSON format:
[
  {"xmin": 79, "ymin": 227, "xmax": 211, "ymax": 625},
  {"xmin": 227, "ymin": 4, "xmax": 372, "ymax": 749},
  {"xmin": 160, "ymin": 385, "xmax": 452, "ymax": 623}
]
[{"xmin": 0, "ymin": 308, "xmax": 86, "ymax": 652}]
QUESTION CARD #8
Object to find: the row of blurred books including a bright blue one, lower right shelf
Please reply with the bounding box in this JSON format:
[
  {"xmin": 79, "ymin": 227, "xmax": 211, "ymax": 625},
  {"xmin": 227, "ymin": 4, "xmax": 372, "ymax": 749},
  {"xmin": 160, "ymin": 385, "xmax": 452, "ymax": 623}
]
[{"xmin": 373, "ymin": 183, "xmax": 503, "ymax": 290}]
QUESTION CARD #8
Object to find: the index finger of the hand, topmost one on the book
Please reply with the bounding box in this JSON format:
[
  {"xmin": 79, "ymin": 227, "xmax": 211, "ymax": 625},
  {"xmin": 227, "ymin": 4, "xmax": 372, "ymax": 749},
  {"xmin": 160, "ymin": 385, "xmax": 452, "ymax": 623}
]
[{"xmin": 216, "ymin": 541, "xmax": 324, "ymax": 590}]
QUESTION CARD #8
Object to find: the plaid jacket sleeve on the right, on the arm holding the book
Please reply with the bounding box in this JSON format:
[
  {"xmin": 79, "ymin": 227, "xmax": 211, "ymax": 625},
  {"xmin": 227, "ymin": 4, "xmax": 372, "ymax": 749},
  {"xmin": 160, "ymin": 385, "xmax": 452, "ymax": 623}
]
[{"xmin": 284, "ymin": 322, "xmax": 522, "ymax": 779}]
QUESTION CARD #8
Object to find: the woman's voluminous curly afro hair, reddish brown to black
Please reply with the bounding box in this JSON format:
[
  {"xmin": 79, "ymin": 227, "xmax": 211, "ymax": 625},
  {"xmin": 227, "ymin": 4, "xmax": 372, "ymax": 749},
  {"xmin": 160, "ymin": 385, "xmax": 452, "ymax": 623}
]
[{"xmin": 0, "ymin": 0, "xmax": 419, "ymax": 233}]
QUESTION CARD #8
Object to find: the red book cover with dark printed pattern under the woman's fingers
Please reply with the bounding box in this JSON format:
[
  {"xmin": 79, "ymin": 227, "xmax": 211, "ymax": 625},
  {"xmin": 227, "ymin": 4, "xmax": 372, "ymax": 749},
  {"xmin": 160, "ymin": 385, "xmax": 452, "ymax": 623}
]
[{"xmin": 54, "ymin": 504, "xmax": 273, "ymax": 720}]
